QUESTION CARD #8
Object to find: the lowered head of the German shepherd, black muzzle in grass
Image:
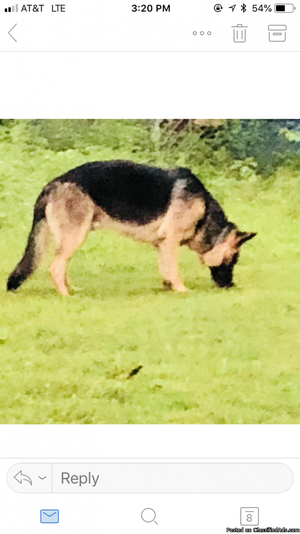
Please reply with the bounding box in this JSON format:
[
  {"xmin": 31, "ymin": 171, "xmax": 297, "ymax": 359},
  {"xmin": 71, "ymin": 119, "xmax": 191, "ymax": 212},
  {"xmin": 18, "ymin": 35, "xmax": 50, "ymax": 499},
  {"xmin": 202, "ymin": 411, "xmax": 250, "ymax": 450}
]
[{"xmin": 201, "ymin": 227, "xmax": 256, "ymax": 288}]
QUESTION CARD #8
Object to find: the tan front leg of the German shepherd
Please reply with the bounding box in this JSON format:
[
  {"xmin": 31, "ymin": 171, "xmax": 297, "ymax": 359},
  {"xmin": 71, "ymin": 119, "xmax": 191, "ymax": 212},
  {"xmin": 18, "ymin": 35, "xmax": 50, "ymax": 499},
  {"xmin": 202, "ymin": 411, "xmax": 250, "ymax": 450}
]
[{"xmin": 157, "ymin": 237, "xmax": 187, "ymax": 292}]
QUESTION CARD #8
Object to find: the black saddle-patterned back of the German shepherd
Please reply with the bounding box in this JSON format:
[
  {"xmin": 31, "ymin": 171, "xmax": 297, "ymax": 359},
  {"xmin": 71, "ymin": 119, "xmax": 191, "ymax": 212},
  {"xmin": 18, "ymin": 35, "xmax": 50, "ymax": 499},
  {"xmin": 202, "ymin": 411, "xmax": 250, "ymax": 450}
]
[{"xmin": 51, "ymin": 160, "xmax": 205, "ymax": 225}]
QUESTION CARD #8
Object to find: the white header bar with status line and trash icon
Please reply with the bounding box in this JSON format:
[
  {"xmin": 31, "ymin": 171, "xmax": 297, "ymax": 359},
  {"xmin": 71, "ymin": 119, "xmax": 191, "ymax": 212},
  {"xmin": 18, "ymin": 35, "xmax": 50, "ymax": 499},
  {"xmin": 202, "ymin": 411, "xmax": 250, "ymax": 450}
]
[{"xmin": 0, "ymin": 0, "xmax": 300, "ymax": 51}]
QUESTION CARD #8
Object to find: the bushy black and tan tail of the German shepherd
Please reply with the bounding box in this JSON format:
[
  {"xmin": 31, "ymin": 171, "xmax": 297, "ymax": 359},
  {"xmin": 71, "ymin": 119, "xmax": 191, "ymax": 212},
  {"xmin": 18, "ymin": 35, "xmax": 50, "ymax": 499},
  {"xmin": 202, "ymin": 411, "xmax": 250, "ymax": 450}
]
[{"xmin": 7, "ymin": 191, "xmax": 48, "ymax": 291}]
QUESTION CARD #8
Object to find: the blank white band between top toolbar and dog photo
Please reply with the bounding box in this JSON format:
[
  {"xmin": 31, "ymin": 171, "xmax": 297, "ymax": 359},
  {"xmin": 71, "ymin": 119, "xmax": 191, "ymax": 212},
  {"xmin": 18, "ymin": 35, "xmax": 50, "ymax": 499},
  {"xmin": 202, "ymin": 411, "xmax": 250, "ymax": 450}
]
[{"xmin": 0, "ymin": 52, "xmax": 300, "ymax": 119}]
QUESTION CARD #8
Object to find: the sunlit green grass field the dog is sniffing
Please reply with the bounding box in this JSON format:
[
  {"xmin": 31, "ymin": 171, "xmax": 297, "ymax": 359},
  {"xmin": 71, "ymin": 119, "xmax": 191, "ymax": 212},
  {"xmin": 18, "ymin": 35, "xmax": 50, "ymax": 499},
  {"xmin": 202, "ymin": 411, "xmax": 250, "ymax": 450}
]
[{"xmin": 0, "ymin": 129, "xmax": 300, "ymax": 424}]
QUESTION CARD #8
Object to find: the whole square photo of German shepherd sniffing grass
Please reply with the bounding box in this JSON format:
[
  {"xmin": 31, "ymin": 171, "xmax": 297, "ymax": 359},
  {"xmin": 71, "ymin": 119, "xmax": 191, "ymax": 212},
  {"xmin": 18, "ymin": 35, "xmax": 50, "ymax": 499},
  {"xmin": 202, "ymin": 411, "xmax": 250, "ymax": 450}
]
[{"xmin": 0, "ymin": 119, "xmax": 300, "ymax": 425}]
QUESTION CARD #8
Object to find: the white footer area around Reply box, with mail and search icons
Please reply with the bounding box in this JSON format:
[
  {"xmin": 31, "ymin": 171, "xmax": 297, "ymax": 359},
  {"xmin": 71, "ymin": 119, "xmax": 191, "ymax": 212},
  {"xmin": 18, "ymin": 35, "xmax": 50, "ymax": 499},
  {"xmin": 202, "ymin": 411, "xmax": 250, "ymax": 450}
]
[{"xmin": 0, "ymin": 459, "xmax": 300, "ymax": 534}]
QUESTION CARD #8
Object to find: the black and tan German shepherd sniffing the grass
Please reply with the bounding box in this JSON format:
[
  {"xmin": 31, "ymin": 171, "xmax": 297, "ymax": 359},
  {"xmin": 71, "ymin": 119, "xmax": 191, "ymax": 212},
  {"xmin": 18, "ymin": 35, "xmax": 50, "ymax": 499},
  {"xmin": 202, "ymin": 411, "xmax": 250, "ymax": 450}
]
[{"xmin": 7, "ymin": 161, "xmax": 256, "ymax": 295}]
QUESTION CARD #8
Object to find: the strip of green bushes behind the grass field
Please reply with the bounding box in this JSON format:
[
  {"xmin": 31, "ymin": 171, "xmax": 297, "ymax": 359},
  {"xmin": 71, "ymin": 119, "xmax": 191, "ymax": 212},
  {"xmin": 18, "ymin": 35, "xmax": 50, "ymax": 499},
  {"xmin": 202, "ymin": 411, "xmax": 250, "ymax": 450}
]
[{"xmin": 0, "ymin": 119, "xmax": 300, "ymax": 180}]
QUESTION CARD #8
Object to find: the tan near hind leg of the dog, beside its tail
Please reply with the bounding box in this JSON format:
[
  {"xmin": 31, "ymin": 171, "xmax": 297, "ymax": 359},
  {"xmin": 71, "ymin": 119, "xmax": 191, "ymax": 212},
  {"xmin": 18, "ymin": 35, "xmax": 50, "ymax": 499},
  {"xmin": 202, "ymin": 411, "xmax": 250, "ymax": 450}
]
[{"xmin": 46, "ymin": 186, "xmax": 94, "ymax": 295}]
